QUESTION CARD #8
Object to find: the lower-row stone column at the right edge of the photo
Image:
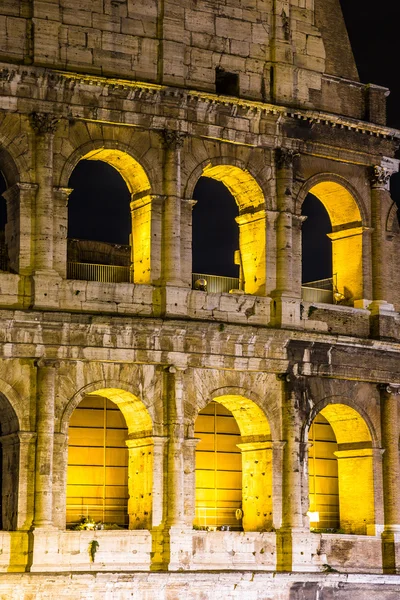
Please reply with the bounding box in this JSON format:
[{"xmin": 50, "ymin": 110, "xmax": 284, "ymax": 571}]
[{"xmin": 380, "ymin": 384, "xmax": 400, "ymax": 573}]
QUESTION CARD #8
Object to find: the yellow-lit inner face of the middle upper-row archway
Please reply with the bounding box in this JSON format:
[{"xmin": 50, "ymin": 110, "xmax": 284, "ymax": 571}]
[{"xmin": 193, "ymin": 165, "xmax": 266, "ymax": 294}]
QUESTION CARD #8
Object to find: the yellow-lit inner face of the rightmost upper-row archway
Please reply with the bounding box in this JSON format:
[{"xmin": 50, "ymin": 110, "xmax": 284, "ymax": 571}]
[{"xmin": 303, "ymin": 181, "xmax": 364, "ymax": 304}]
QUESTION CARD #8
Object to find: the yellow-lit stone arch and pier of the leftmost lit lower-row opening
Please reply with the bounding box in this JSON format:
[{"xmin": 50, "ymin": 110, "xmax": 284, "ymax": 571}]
[{"xmin": 61, "ymin": 382, "xmax": 154, "ymax": 529}]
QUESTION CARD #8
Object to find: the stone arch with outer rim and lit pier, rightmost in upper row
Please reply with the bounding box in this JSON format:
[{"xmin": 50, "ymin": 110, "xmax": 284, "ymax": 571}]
[{"xmin": 296, "ymin": 173, "xmax": 369, "ymax": 303}]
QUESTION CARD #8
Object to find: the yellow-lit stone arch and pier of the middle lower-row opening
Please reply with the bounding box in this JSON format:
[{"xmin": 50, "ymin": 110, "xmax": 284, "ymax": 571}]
[{"xmin": 195, "ymin": 388, "xmax": 273, "ymax": 531}]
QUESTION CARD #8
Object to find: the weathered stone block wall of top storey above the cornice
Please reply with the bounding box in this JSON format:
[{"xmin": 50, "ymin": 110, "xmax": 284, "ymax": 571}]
[{"xmin": 0, "ymin": 0, "xmax": 385, "ymax": 118}]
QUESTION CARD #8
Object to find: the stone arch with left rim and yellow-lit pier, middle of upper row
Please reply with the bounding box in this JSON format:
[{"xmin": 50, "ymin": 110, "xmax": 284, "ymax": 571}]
[{"xmin": 185, "ymin": 157, "xmax": 266, "ymax": 295}]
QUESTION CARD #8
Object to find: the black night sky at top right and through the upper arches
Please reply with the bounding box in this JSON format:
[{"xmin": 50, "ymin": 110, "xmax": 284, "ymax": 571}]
[{"xmin": 0, "ymin": 0, "xmax": 400, "ymax": 281}]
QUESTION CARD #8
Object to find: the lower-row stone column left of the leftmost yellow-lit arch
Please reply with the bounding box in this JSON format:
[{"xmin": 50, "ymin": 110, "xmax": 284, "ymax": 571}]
[{"xmin": 33, "ymin": 359, "xmax": 59, "ymax": 528}]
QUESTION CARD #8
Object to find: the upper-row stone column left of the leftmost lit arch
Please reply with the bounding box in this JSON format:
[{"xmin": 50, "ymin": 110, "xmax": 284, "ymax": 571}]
[{"xmin": 31, "ymin": 113, "xmax": 59, "ymax": 271}]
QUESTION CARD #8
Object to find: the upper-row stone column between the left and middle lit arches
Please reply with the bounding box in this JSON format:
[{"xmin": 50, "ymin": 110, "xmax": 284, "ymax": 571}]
[{"xmin": 163, "ymin": 129, "xmax": 184, "ymax": 286}]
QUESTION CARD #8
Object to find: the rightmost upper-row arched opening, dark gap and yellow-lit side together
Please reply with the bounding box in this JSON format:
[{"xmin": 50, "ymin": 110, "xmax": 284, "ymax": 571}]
[{"xmin": 302, "ymin": 181, "xmax": 364, "ymax": 305}]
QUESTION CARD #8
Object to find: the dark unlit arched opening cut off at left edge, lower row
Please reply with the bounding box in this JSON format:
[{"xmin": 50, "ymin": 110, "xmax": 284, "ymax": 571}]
[{"xmin": 0, "ymin": 394, "xmax": 20, "ymax": 531}]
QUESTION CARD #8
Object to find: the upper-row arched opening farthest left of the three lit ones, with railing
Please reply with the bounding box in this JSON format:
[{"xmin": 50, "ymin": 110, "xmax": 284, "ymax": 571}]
[{"xmin": 67, "ymin": 149, "xmax": 151, "ymax": 283}]
